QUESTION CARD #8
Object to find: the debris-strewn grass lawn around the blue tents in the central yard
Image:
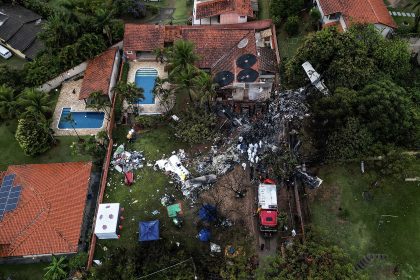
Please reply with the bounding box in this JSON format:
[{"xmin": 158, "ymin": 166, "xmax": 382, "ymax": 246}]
[{"xmin": 95, "ymin": 126, "xmax": 253, "ymax": 276}]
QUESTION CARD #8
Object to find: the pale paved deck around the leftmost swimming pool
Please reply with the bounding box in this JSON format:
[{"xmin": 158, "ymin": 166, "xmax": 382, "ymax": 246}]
[{"xmin": 51, "ymin": 79, "xmax": 109, "ymax": 136}]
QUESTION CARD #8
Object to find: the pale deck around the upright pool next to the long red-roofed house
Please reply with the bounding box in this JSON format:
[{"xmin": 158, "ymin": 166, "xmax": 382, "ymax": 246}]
[{"xmin": 125, "ymin": 61, "xmax": 169, "ymax": 114}]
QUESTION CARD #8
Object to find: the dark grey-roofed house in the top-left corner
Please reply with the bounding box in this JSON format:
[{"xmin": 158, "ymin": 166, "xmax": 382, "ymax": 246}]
[{"xmin": 0, "ymin": 4, "xmax": 44, "ymax": 60}]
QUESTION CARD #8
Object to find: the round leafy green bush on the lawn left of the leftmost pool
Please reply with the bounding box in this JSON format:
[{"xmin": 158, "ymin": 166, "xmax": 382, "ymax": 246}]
[{"xmin": 15, "ymin": 116, "xmax": 55, "ymax": 156}]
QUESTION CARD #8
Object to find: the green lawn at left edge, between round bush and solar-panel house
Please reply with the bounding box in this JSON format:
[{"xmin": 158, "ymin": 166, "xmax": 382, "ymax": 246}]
[{"xmin": 0, "ymin": 121, "xmax": 89, "ymax": 170}]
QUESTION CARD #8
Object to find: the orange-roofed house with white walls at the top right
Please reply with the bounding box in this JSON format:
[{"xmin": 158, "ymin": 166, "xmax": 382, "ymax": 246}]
[{"xmin": 314, "ymin": 0, "xmax": 397, "ymax": 37}]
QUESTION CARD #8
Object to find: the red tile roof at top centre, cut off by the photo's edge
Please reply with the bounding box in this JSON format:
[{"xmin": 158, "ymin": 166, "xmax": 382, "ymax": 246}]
[{"xmin": 195, "ymin": 0, "xmax": 254, "ymax": 18}]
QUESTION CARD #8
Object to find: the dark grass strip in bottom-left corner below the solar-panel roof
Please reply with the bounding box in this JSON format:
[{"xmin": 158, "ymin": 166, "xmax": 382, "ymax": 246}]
[{"xmin": 0, "ymin": 263, "xmax": 48, "ymax": 280}]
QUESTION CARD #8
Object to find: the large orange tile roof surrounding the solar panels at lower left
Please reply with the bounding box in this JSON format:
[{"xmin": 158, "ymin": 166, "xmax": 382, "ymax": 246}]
[{"xmin": 0, "ymin": 162, "xmax": 92, "ymax": 257}]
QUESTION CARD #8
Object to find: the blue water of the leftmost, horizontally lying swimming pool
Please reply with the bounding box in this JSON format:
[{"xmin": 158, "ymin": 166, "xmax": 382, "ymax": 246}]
[{"xmin": 58, "ymin": 108, "xmax": 105, "ymax": 129}]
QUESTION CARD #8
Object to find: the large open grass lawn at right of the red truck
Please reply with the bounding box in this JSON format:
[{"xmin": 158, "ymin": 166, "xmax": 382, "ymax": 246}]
[{"xmin": 311, "ymin": 160, "xmax": 420, "ymax": 279}]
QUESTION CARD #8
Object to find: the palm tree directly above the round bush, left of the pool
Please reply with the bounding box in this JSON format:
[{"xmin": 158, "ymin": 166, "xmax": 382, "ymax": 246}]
[{"xmin": 17, "ymin": 88, "xmax": 52, "ymax": 119}]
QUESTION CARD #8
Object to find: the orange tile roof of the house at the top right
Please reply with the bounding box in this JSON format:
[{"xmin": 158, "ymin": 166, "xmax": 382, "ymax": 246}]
[{"xmin": 319, "ymin": 0, "xmax": 397, "ymax": 28}]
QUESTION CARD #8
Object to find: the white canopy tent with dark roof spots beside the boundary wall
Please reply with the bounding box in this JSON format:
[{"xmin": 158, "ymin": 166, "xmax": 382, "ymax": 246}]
[{"xmin": 95, "ymin": 203, "xmax": 120, "ymax": 239}]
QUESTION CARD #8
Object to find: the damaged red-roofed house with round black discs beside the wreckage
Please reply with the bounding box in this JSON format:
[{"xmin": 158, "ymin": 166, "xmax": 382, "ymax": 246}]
[{"xmin": 124, "ymin": 20, "xmax": 280, "ymax": 102}]
